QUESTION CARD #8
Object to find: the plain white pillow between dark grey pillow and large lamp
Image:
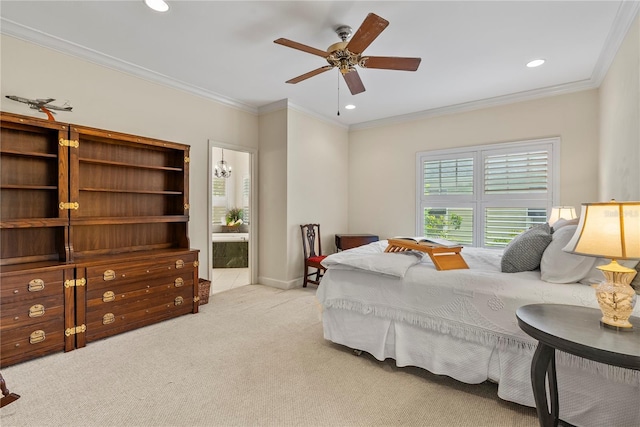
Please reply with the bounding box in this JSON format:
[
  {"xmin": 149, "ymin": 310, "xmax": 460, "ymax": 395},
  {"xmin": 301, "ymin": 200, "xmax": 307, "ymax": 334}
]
[{"xmin": 540, "ymin": 221, "xmax": 597, "ymax": 283}]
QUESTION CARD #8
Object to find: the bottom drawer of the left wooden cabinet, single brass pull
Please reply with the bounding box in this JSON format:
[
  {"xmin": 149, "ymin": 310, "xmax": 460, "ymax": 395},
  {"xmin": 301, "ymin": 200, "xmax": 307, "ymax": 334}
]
[{"xmin": 0, "ymin": 318, "xmax": 65, "ymax": 367}]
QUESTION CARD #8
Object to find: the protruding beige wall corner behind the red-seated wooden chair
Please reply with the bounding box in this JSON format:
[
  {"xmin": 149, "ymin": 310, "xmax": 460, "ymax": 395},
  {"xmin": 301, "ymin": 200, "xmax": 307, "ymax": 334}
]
[{"xmin": 258, "ymin": 108, "xmax": 348, "ymax": 289}]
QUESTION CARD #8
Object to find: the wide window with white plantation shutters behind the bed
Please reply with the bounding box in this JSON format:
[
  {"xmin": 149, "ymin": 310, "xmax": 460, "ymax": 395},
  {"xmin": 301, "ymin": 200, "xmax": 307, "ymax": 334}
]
[{"xmin": 416, "ymin": 138, "xmax": 559, "ymax": 247}]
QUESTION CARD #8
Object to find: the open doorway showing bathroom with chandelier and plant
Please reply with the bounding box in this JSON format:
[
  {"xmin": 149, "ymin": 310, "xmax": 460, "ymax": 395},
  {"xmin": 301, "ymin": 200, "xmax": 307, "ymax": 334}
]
[{"xmin": 207, "ymin": 140, "xmax": 257, "ymax": 294}]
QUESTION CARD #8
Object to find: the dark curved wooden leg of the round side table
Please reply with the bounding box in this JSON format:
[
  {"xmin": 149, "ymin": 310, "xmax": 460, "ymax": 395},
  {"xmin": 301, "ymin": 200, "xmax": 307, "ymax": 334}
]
[{"xmin": 531, "ymin": 343, "xmax": 559, "ymax": 427}]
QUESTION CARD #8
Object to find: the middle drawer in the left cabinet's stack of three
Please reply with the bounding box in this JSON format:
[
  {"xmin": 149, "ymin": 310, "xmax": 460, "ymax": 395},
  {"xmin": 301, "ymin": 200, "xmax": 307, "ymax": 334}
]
[{"xmin": 0, "ymin": 295, "xmax": 64, "ymax": 332}]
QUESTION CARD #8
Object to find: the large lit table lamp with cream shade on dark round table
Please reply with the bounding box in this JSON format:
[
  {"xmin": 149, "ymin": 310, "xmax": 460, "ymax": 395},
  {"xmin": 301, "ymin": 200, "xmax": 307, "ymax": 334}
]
[{"xmin": 563, "ymin": 200, "xmax": 640, "ymax": 330}]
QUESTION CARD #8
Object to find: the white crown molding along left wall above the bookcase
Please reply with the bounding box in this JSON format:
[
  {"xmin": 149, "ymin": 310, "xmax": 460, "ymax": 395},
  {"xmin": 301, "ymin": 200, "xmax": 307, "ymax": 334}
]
[{"xmin": 0, "ymin": 17, "xmax": 258, "ymax": 114}]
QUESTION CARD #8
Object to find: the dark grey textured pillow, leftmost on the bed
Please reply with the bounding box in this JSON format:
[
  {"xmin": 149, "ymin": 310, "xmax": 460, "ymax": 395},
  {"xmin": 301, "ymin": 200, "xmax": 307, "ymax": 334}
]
[{"xmin": 501, "ymin": 223, "xmax": 551, "ymax": 273}]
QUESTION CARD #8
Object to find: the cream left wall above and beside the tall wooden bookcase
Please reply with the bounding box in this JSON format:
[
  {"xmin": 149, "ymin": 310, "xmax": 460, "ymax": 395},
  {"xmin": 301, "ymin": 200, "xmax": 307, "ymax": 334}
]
[{"xmin": 0, "ymin": 35, "xmax": 258, "ymax": 277}]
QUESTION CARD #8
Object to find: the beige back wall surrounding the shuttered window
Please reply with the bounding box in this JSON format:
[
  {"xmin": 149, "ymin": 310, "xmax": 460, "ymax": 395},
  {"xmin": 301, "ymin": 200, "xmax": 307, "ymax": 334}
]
[{"xmin": 348, "ymin": 90, "xmax": 598, "ymax": 238}]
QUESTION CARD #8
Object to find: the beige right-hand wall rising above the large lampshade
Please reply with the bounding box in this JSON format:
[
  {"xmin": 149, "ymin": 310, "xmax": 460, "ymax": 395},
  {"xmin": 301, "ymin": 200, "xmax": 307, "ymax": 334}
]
[{"xmin": 599, "ymin": 16, "xmax": 640, "ymax": 201}]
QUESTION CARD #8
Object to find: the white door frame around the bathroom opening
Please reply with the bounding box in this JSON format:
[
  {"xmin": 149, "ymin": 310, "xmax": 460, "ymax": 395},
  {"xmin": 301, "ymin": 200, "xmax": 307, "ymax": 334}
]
[{"xmin": 207, "ymin": 139, "xmax": 259, "ymax": 285}]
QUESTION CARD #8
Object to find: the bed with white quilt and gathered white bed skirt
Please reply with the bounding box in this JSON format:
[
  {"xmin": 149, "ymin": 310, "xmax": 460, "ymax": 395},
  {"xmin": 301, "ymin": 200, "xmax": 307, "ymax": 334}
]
[{"xmin": 317, "ymin": 229, "xmax": 640, "ymax": 426}]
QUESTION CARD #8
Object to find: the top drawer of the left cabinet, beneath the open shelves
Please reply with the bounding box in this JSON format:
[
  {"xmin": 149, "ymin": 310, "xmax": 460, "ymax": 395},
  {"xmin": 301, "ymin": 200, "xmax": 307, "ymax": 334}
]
[{"xmin": 0, "ymin": 270, "xmax": 64, "ymax": 306}]
